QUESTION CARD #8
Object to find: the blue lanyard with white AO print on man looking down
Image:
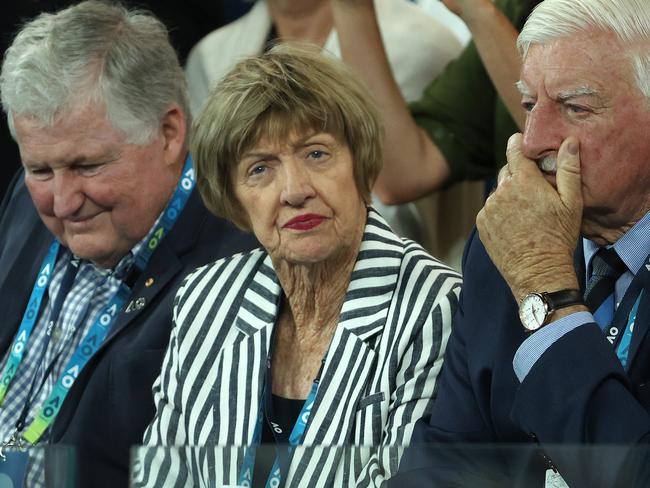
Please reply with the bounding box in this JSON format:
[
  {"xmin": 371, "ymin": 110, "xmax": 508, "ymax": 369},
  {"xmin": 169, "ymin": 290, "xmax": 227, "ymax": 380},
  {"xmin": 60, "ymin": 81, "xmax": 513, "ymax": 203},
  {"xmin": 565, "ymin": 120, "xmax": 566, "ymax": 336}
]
[{"xmin": 0, "ymin": 155, "xmax": 195, "ymax": 444}]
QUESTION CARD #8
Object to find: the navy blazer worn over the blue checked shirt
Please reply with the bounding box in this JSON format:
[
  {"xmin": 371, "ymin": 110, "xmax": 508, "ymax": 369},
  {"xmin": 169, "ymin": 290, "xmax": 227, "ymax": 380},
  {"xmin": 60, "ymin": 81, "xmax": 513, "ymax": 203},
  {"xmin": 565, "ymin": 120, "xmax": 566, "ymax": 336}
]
[{"xmin": 0, "ymin": 170, "xmax": 257, "ymax": 487}]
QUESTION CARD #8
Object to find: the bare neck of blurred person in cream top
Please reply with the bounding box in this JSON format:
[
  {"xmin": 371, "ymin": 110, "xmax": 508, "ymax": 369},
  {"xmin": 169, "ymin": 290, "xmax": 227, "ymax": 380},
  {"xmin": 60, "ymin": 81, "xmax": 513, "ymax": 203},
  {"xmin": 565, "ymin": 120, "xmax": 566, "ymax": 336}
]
[{"xmin": 267, "ymin": 0, "xmax": 334, "ymax": 47}]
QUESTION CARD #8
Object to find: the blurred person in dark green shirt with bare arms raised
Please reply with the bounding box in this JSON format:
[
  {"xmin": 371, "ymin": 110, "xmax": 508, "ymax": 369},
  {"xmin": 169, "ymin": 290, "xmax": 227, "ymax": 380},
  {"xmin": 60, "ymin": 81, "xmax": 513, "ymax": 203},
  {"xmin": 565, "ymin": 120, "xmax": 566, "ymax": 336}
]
[{"xmin": 331, "ymin": 0, "xmax": 539, "ymax": 266}]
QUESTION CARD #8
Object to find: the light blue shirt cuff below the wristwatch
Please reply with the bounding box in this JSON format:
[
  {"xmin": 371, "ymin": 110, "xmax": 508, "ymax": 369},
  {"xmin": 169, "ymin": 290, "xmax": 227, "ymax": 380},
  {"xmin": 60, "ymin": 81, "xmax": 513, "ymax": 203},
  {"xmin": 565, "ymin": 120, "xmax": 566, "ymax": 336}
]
[{"xmin": 512, "ymin": 312, "xmax": 594, "ymax": 383}]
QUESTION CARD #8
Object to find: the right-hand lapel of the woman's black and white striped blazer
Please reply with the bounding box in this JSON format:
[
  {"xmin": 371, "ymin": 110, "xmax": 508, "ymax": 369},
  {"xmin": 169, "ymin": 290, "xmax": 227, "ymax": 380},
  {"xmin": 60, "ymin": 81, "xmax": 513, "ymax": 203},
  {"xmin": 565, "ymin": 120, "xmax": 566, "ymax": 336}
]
[{"xmin": 288, "ymin": 208, "xmax": 404, "ymax": 478}]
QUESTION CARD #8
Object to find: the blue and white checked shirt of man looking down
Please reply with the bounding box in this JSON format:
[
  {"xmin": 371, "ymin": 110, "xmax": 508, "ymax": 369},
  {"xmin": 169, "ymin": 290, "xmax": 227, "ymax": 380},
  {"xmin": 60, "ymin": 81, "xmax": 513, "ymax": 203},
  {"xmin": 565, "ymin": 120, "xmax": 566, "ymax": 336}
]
[{"xmin": 0, "ymin": 234, "xmax": 149, "ymax": 487}]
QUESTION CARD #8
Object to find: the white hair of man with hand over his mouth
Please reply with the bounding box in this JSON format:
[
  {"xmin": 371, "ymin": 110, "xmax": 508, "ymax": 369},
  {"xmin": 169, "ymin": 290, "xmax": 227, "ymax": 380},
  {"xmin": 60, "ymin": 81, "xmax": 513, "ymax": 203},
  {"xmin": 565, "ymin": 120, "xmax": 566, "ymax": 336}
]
[{"xmin": 517, "ymin": 0, "xmax": 650, "ymax": 98}]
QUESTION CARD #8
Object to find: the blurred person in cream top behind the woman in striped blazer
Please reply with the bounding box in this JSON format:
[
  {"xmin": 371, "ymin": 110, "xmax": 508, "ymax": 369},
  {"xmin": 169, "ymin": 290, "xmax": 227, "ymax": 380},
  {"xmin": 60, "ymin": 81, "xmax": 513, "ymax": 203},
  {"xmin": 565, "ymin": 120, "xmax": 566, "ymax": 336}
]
[{"xmin": 186, "ymin": 0, "xmax": 482, "ymax": 268}]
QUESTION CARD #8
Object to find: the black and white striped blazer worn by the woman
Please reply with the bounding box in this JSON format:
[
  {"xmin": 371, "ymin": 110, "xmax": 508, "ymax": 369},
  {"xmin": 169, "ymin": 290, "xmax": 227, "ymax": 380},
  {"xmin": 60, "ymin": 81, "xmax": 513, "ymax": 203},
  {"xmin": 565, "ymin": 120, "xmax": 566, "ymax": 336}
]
[{"xmin": 134, "ymin": 208, "xmax": 461, "ymax": 487}]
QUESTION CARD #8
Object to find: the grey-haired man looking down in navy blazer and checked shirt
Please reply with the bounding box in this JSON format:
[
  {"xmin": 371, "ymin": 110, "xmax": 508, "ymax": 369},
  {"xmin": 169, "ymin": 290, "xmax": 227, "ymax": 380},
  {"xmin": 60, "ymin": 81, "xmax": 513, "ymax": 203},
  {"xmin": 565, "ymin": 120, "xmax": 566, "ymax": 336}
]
[{"xmin": 0, "ymin": 1, "xmax": 254, "ymax": 487}]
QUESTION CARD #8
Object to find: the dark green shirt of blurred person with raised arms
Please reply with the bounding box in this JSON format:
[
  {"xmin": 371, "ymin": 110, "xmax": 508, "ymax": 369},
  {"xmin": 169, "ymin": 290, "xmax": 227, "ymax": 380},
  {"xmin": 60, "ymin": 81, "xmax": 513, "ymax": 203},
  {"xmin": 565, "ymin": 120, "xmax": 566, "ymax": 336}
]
[{"xmin": 410, "ymin": 0, "xmax": 539, "ymax": 185}]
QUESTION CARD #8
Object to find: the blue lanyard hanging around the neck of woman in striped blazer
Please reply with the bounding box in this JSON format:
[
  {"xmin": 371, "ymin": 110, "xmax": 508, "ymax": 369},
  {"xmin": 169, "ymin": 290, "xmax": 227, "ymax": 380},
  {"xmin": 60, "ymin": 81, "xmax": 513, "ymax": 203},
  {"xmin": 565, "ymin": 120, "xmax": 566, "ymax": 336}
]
[{"xmin": 239, "ymin": 331, "xmax": 325, "ymax": 488}]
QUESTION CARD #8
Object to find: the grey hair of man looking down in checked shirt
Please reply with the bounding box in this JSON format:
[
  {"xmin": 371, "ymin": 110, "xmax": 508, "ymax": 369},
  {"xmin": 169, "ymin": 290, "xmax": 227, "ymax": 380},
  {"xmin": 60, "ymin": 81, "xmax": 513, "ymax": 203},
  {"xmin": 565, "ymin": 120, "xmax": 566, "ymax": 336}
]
[{"xmin": 0, "ymin": 0, "xmax": 191, "ymax": 144}]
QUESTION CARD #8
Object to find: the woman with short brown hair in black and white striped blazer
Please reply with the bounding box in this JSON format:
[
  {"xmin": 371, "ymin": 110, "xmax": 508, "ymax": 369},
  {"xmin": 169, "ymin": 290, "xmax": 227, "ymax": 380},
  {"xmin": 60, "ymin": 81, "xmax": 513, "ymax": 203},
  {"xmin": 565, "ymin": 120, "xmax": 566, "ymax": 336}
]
[{"xmin": 139, "ymin": 46, "xmax": 460, "ymax": 486}]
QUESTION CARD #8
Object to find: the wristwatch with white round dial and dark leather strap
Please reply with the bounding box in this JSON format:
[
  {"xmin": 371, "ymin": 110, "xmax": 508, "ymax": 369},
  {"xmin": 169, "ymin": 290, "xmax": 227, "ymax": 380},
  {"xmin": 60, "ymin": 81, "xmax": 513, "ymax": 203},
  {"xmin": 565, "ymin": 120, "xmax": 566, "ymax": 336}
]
[{"xmin": 519, "ymin": 289, "xmax": 584, "ymax": 332}]
